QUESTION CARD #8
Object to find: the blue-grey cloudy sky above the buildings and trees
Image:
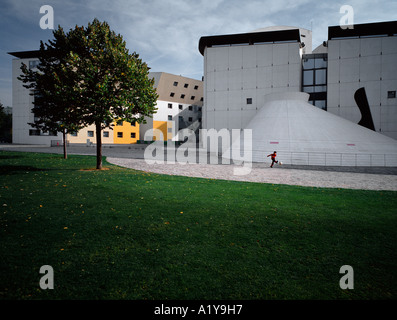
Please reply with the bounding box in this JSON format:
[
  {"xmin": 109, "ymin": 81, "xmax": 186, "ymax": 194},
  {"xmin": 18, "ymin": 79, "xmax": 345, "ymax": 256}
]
[{"xmin": 0, "ymin": 0, "xmax": 397, "ymax": 106}]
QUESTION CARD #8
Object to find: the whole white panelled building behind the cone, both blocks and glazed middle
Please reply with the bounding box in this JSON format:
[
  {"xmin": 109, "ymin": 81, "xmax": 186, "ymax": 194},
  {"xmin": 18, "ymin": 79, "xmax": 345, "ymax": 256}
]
[{"xmin": 199, "ymin": 21, "xmax": 397, "ymax": 151}]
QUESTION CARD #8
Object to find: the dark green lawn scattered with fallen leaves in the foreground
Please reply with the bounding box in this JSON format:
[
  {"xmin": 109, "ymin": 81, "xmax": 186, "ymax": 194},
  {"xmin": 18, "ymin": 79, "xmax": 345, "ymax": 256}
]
[{"xmin": 0, "ymin": 152, "xmax": 397, "ymax": 300}]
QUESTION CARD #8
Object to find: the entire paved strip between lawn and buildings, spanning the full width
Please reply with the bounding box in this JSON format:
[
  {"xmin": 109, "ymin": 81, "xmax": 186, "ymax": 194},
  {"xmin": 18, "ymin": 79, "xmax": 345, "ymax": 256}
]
[{"xmin": 0, "ymin": 145, "xmax": 397, "ymax": 191}]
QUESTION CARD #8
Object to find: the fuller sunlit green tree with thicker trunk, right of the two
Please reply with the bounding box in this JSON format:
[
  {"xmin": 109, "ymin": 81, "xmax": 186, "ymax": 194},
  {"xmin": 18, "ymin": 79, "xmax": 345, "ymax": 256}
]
[{"xmin": 67, "ymin": 19, "xmax": 158, "ymax": 169}]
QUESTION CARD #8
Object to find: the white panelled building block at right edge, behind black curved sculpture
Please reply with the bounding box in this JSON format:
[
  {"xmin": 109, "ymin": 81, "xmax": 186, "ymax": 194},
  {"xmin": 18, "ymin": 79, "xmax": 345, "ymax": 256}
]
[{"xmin": 327, "ymin": 21, "xmax": 397, "ymax": 139}]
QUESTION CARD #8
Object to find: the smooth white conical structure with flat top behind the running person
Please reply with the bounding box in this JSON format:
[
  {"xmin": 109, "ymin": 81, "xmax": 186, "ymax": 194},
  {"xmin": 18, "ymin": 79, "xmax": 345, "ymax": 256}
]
[{"xmin": 223, "ymin": 92, "xmax": 397, "ymax": 166}]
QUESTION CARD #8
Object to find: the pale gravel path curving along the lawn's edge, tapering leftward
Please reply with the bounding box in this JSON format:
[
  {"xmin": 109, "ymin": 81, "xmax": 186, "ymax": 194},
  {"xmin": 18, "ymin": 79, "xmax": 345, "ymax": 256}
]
[{"xmin": 107, "ymin": 157, "xmax": 397, "ymax": 191}]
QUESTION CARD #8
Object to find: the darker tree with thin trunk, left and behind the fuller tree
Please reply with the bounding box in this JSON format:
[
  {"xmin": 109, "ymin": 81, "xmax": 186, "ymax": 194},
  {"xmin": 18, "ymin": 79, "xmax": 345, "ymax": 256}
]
[{"xmin": 18, "ymin": 28, "xmax": 84, "ymax": 159}]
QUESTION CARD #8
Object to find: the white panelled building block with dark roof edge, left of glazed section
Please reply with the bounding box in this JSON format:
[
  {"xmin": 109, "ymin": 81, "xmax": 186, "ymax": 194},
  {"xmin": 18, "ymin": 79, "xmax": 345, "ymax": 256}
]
[{"xmin": 199, "ymin": 27, "xmax": 311, "ymax": 134}]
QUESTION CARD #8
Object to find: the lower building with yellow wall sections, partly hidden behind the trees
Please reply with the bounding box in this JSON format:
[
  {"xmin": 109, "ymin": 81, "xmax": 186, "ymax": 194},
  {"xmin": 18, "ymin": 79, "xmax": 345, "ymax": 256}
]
[{"xmin": 10, "ymin": 51, "xmax": 203, "ymax": 145}]
